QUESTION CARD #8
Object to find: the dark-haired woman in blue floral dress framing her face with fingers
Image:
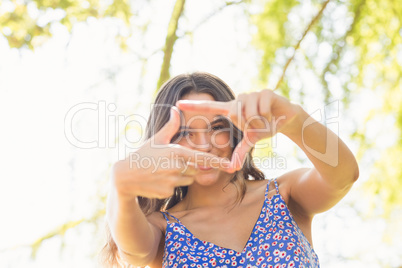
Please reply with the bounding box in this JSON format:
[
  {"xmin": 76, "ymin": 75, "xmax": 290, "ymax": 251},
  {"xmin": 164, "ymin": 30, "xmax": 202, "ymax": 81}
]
[{"xmin": 104, "ymin": 73, "xmax": 358, "ymax": 268}]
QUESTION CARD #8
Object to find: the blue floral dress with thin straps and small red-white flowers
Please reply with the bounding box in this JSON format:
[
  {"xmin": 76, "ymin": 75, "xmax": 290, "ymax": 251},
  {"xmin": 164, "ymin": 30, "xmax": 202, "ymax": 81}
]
[{"xmin": 162, "ymin": 179, "xmax": 320, "ymax": 268}]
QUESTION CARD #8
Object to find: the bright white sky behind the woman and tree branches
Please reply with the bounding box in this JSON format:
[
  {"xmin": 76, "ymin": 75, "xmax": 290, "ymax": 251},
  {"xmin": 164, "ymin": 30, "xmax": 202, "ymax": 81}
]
[{"xmin": 0, "ymin": 0, "xmax": 402, "ymax": 268}]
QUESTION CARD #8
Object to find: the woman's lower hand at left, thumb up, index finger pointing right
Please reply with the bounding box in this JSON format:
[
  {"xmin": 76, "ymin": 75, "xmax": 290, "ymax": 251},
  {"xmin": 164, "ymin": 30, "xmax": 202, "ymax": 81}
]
[{"xmin": 113, "ymin": 107, "xmax": 230, "ymax": 199}]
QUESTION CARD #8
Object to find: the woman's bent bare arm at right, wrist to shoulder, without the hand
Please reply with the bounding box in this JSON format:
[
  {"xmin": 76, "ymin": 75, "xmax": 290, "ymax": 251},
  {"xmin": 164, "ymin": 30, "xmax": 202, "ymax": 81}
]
[{"xmin": 280, "ymin": 104, "xmax": 359, "ymax": 215}]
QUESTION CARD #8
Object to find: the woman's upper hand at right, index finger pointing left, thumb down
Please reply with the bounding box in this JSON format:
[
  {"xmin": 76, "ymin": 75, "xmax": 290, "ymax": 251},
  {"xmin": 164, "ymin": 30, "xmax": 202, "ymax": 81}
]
[{"xmin": 176, "ymin": 89, "xmax": 298, "ymax": 170}]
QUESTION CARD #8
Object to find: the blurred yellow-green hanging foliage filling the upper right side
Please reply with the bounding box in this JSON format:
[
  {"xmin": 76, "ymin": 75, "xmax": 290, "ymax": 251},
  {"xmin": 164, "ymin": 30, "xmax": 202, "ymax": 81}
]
[{"xmin": 252, "ymin": 0, "xmax": 402, "ymax": 216}]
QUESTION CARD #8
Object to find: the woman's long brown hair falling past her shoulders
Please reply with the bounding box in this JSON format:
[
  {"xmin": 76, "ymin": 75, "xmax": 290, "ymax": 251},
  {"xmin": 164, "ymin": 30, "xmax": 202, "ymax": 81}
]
[{"xmin": 101, "ymin": 72, "xmax": 264, "ymax": 267}]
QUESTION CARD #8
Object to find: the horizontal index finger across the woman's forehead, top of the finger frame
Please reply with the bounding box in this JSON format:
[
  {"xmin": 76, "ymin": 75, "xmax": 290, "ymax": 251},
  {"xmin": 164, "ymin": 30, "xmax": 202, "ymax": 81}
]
[{"xmin": 176, "ymin": 100, "xmax": 231, "ymax": 115}]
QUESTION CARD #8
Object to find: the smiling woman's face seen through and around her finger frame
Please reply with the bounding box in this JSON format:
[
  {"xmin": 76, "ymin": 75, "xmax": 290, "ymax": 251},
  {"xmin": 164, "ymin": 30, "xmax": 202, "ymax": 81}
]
[{"xmin": 175, "ymin": 93, "xmax": 232, "ymax": 185}]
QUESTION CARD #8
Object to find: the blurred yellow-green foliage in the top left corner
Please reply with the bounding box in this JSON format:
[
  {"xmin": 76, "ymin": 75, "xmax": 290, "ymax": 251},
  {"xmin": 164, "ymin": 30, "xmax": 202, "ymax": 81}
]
[{"xmin": 0, "ymin": 0, "xmax": 132, "ymax": 49}]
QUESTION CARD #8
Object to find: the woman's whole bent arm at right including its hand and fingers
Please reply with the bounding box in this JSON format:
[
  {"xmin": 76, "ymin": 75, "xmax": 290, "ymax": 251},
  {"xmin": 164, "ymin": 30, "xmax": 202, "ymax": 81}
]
[{"xmin": 176, "ymin": 90, "xmax": 359, "ymax": 216}]
